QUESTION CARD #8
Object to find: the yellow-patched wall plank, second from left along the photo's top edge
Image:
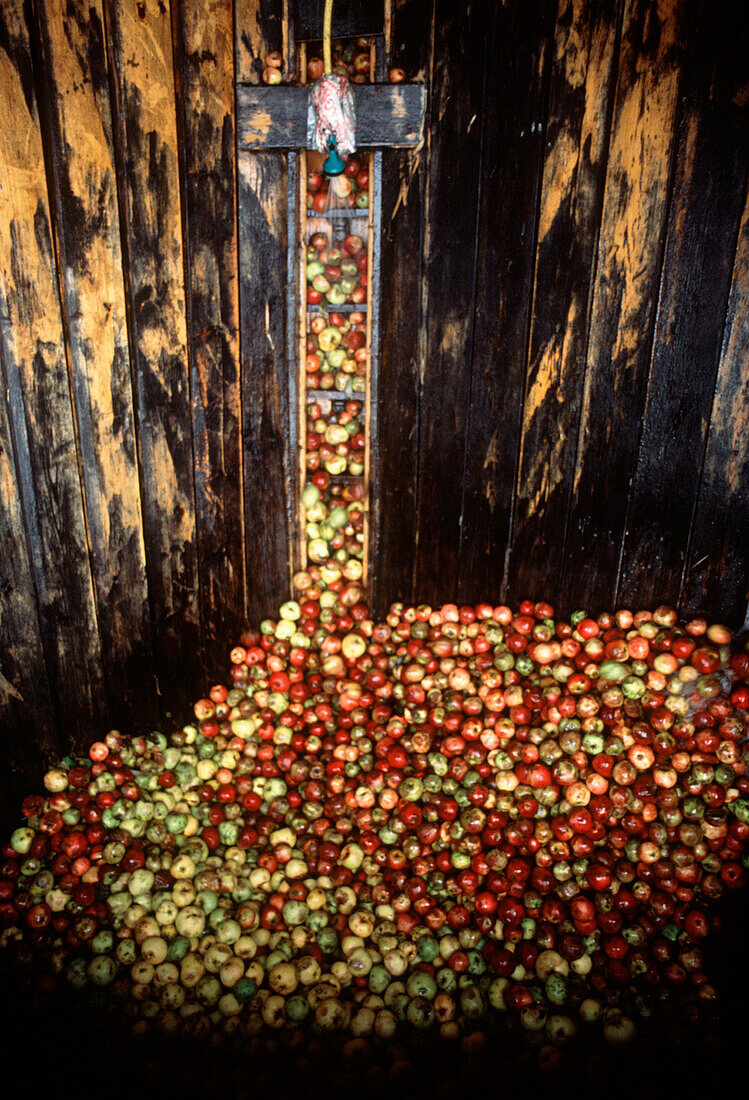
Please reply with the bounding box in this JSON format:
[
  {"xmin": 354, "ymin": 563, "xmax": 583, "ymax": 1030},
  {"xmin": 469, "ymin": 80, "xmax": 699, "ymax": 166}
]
[{"xmin": 36, "ymin": 0, "xmax": 157, "ymax": 728}]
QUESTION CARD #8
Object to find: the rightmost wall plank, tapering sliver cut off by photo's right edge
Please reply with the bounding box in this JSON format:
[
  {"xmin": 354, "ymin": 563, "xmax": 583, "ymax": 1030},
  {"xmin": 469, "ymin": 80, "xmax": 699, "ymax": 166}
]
[{"xmin": 682, "ymin": 181, "xmax": 749, "ymax": 628}]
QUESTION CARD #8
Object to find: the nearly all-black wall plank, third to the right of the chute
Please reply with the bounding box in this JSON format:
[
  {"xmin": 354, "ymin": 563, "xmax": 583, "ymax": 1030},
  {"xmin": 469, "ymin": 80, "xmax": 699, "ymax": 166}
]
[{"xmin": 456, "ymin": 0, "xmax": 557, "ymax": 601}]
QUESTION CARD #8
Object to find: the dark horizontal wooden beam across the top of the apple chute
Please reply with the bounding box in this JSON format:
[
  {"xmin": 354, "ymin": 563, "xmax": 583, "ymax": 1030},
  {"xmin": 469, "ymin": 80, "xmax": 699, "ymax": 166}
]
[{"xmin": 236, "ymin": 84, "xmax": 427, "ymax": 150}]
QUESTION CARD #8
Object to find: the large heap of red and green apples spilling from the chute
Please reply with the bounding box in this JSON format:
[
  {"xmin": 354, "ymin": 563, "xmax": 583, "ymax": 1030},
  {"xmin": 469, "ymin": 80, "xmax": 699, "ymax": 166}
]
[{"xmin": 0, "ymin": 567, "xmax": 749, "ymax": 1063}]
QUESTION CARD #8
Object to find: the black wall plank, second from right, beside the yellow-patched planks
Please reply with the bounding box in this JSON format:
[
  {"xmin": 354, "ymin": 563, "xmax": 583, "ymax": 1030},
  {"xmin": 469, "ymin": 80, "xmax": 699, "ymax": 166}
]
[{"xmin": 618, "ymin": 3, "xmax": 749, "ymax": 607}]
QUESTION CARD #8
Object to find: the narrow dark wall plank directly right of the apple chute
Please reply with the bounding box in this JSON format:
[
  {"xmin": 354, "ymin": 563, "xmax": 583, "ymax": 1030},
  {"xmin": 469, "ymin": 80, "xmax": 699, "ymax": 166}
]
[{"xmin": 370, "ymin": 0, "xmax": 433, "ymax": 615}]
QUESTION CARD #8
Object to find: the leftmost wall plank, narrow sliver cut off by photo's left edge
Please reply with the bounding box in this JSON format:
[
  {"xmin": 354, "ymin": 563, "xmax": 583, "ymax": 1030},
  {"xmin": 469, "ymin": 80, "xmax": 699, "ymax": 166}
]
[{"xmin": 0, "ymin": 308, "xmax": 56, "ymax": 823}]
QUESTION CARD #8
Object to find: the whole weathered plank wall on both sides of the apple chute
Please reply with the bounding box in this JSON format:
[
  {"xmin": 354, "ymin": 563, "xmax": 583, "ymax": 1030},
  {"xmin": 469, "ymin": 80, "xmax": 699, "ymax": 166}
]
[{"xmin": 0, "ymin": 0, "xmax": 749, "ymax": 822}]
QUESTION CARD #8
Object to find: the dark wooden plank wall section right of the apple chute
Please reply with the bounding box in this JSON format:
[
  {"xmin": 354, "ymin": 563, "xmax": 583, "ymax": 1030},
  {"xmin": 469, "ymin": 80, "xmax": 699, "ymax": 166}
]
[{"xmin": 380, "ymin": 0, "xmax": 749, "ymax": 627}]
